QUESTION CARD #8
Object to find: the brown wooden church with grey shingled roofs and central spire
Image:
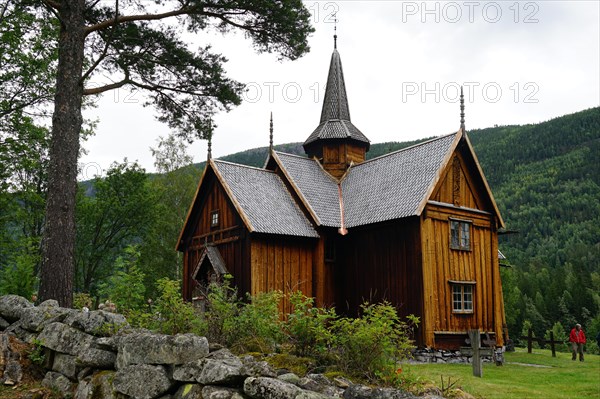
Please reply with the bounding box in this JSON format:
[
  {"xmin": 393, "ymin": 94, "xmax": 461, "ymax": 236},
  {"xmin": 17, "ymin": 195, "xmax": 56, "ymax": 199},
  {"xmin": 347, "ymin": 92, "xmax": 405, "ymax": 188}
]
[{"xmin": 177, "ymin": 38, "xmax": 505, "ymax": 349}]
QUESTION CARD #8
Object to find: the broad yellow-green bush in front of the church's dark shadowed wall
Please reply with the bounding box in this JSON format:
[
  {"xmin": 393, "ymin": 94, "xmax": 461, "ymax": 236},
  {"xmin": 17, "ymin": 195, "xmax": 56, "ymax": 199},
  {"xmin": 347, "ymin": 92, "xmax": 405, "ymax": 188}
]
[{"xmin": 333, "ymin": 302, "xmax": 418, "ymax": 380}]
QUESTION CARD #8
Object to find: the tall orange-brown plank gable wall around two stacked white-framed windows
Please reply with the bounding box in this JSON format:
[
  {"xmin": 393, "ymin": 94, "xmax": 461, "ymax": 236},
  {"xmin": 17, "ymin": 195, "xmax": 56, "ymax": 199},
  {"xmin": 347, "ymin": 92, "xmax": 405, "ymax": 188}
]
[{"xmin": 421, "ymin": 145, "xmax": 504, "ymax": 349}]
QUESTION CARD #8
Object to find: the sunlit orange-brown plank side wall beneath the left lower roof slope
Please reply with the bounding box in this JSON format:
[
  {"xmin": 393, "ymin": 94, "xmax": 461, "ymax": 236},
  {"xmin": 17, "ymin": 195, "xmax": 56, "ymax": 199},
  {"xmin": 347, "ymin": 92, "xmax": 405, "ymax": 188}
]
[{"xmin": 250, "ymin": 234, "xmax": 317, "ymax": 313}]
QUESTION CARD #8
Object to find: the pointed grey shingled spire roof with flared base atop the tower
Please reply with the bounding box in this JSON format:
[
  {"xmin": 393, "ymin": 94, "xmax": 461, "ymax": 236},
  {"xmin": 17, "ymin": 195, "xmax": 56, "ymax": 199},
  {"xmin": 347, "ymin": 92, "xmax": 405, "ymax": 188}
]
[{"xmin": 304, "ymin": 49, "xmax": 369, "ymax": 149}]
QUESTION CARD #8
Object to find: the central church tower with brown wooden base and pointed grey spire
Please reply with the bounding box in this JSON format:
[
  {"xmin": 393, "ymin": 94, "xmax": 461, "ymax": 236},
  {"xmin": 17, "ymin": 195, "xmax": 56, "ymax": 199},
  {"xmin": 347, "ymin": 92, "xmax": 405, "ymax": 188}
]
[{"xmin": 303, "ymin": 35, "xmax": 370, "ymax": 179}]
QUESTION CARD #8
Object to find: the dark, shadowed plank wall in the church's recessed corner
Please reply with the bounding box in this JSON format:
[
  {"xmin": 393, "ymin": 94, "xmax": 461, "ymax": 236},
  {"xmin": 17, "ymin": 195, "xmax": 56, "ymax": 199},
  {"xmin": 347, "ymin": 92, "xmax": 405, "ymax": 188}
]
[{"xmin": 333, "ymin": 217, "xmax": 423, "ymax": 345}]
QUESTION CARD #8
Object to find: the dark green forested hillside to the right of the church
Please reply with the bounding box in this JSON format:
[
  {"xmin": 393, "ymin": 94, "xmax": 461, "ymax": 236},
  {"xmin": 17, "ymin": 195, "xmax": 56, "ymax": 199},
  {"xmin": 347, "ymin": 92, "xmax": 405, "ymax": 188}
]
[{"xmin": 469, "ymin": 108, "xmax": 600, "ymax": 336}]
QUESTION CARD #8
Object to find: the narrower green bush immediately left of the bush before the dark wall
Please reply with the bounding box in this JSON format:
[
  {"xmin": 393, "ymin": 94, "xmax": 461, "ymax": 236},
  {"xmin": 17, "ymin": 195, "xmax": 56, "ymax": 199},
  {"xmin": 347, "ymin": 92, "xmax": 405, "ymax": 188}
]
[{"xmin": 285, "ymin": 291, "xmax": 337, "ymax": 359}]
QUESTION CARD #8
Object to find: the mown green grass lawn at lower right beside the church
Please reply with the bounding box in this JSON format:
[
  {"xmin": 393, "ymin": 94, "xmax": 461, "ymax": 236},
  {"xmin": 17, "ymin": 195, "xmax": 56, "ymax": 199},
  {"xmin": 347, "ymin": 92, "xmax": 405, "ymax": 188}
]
[{"xmin": 403, "ymin": 348, "xmax": 600, "ymax": 399}]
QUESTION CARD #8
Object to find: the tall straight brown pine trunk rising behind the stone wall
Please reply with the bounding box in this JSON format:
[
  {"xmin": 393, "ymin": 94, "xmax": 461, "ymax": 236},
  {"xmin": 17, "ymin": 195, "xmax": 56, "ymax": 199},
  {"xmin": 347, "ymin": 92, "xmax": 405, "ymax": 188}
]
[{"xmin": 38, "ymin": 0, "xmax": 85, "ymax": 307}]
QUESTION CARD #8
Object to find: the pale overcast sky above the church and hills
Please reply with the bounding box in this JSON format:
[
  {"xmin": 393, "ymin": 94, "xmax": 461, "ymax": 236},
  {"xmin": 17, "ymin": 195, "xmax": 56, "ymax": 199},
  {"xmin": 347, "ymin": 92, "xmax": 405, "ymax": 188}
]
[{"xmin": 80, "ymin": 0, "xmax": 600, "ymax": 179}]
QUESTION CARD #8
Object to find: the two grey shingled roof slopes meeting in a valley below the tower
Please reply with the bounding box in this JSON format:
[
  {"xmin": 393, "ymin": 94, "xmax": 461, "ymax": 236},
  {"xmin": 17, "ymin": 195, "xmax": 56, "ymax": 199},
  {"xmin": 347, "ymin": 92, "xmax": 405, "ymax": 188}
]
[{"xmin": 275, "ymin": 132, "xmax": 462, "ymax": 228}]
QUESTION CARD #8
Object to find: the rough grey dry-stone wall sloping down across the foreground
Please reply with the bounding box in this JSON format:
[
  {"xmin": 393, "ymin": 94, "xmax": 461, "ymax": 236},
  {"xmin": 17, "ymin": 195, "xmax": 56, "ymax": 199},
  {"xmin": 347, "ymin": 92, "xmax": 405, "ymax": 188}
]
[{"xmin": 0, "ymin": 295, "xmax": 439, "ymax": 399}]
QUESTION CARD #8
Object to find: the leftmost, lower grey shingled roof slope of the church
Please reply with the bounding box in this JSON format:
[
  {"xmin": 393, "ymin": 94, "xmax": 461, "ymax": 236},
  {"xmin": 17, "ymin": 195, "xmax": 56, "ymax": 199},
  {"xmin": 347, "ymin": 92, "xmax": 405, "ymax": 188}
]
[{"xmin": 212, "ymin": 160, "xmax": 319, "ymax": 237}]
